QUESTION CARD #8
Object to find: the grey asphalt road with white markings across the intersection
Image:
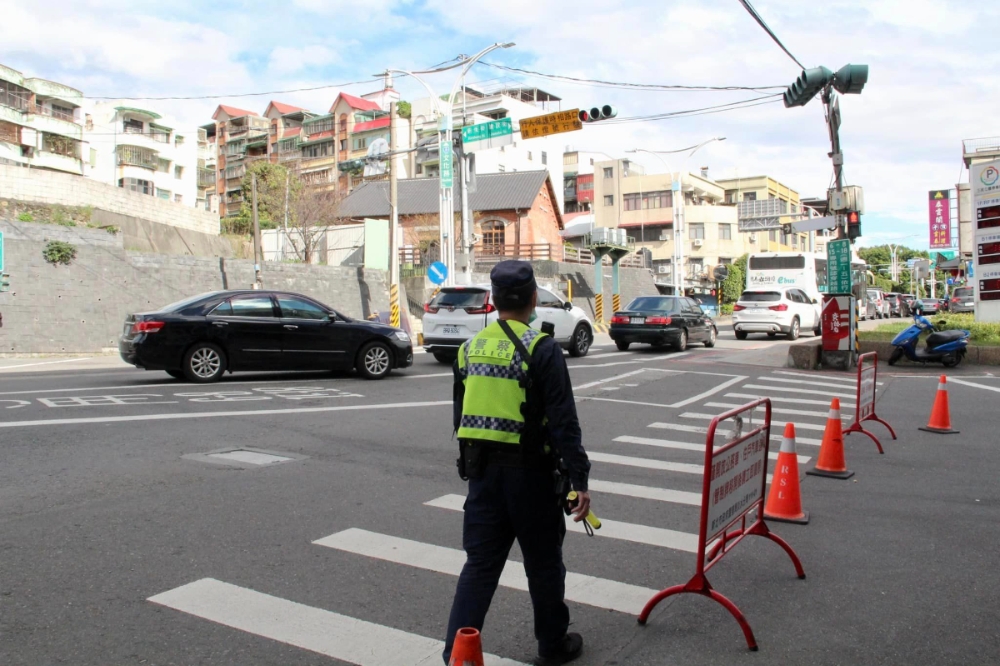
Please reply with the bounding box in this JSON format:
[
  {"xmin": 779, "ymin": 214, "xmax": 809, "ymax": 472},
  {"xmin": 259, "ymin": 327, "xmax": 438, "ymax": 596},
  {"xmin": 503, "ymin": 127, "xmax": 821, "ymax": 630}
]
[{"xmin": 0, "ymin": 331, "xmax": 1000, "ymax": 666}]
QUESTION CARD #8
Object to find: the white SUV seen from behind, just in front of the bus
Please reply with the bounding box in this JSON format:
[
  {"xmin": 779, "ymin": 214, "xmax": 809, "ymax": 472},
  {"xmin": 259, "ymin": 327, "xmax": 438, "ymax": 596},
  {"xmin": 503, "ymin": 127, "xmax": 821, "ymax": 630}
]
[{"xmin": 733, "ymin": 289, "xmax": 822, "ymax": 340}]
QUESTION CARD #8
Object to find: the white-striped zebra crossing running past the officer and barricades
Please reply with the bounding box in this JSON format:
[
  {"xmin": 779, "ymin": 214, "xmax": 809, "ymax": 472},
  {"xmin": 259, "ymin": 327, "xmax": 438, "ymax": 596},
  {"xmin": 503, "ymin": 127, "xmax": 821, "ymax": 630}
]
[{"xmin": 148, "ymin": 371, "xmax": 872, "ymax": 666}]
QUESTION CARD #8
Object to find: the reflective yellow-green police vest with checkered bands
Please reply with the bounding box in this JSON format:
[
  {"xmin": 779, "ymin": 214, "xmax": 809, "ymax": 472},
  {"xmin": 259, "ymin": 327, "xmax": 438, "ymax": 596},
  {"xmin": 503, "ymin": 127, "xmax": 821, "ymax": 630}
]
[{"xmin": 458, "ymin": 321, "xmax": 545, "ymax": 444}]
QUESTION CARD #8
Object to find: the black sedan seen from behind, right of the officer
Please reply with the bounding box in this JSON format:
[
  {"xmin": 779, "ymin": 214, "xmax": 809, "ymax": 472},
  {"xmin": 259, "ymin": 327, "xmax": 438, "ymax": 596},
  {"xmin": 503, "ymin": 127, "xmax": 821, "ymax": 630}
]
[{"xmin": 610, "ymin": 296, "xmax": 719, "ymax": 351}]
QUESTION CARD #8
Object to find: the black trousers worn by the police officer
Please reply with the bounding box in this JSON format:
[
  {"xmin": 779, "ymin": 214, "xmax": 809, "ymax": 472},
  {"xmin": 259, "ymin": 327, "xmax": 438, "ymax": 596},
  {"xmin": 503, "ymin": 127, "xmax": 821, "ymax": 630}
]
[{"xmin": 443, "ymin": 464, "xmax": 569, "ymax": 664}]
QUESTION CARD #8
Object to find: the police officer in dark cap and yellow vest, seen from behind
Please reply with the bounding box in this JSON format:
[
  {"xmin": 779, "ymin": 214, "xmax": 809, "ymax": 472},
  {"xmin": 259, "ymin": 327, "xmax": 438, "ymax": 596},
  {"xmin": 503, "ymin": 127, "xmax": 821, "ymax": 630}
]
[{"xmin": 444, "ymin": 261, "xmax": 590, "ymax": 665}]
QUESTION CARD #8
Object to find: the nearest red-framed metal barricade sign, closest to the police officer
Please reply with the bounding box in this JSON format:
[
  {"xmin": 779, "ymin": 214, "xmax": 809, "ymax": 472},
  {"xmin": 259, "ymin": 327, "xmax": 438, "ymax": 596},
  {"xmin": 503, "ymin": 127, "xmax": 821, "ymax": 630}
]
[{"xmin": 639, "ymin": 398, "xmax": 806, "ymax": 650}]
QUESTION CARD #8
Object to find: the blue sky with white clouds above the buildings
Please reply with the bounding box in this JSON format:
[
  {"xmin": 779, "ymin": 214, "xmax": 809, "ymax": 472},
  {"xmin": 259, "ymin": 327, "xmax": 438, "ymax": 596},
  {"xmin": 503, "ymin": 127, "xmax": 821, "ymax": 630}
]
[{"xmin": 0, "ymin": 0, "xmax": 1000, "ymax": 248}]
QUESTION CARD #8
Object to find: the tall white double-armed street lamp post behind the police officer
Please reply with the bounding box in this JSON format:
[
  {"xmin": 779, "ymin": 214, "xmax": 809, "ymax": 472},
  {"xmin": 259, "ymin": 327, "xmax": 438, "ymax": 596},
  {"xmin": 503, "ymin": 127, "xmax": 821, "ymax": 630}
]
[{"xmin": 378, "ymin": 42, "xmax": 514, "ymax": 285}]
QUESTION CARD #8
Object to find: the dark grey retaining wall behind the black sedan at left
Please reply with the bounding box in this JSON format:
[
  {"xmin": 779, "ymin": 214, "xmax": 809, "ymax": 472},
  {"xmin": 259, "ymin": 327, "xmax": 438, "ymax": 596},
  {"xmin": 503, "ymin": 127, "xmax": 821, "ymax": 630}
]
[{"xmin": 0, "ymin": 221, "xmax": 388, "ymax": 354}]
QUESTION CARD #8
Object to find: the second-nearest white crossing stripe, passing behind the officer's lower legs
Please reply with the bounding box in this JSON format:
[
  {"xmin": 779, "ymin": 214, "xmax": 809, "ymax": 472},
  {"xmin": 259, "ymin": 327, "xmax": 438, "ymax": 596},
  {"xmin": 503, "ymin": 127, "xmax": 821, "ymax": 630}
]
[{"xmin": 313, "ymin": 528, "xmax": 652, "ymax": 615}]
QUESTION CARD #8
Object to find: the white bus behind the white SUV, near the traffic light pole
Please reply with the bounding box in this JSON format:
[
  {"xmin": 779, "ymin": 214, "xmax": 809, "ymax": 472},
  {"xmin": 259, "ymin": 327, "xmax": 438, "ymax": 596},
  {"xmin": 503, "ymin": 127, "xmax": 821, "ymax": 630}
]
[{"xmin": 747, "ymin": 252, "xmax": 868, "ymax": 314}]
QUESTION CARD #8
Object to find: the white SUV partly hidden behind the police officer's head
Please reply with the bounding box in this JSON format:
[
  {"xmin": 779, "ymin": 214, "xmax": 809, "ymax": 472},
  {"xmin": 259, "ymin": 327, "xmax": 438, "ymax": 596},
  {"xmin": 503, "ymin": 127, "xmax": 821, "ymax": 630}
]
[{"xmin": 423, "ymin": 285, "xmax": 594, "ymax": 363}]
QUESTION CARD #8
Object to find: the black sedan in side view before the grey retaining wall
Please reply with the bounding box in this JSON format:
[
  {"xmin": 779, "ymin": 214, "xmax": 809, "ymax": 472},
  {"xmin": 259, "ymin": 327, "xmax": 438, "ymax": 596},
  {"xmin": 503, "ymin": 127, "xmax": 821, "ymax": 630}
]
[{"xmin": 118, "ymin": 290, "xmax": 413, "ymax": 383}]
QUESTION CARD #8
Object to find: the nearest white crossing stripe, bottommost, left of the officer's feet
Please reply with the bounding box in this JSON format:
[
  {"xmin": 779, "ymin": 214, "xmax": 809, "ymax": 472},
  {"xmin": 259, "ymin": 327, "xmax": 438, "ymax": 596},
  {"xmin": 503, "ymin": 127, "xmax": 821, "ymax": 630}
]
[{"xmin": 148, "ymin": 578, "xmax": 520, "ymax": 666}]
